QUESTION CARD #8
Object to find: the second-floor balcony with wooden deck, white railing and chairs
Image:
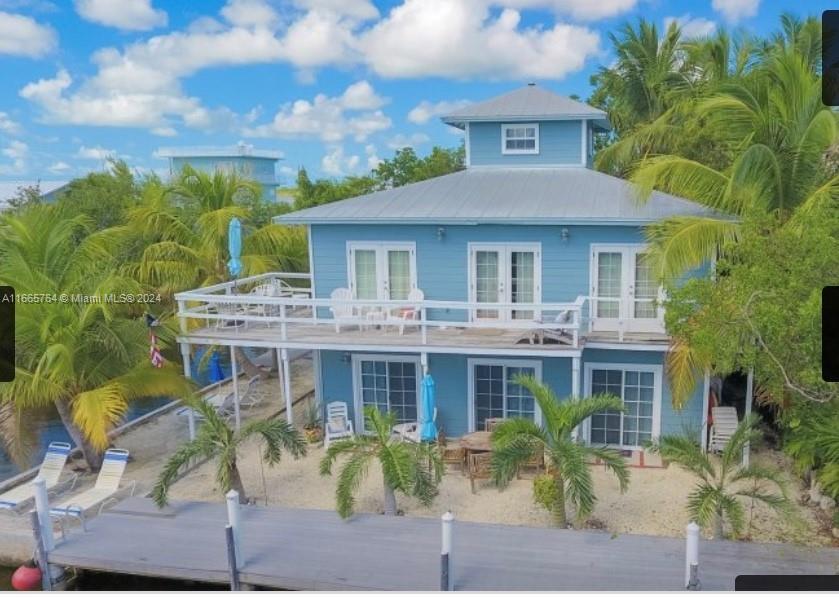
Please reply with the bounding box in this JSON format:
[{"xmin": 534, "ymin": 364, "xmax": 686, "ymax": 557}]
[{"xmin": 176, "ymin": 273, "xmax": 665, "ymax": 354}]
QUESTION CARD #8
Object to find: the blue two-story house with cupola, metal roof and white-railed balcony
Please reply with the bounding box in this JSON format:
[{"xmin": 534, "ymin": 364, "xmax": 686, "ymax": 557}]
[{"xmin": 176, "ymin": 85, "xmax": 707, "ymax": 460}]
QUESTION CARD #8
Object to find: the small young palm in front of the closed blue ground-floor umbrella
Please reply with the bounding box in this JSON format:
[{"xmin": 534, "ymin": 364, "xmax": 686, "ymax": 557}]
[{"xmin": 320, "ymin": 407, "xmax": 443, "ymax": 518}]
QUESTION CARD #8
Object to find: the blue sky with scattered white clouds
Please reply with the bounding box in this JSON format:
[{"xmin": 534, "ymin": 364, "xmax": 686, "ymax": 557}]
[{"xmin": 0, "ymin": 0, "xmax": 839, "ymax": 183}]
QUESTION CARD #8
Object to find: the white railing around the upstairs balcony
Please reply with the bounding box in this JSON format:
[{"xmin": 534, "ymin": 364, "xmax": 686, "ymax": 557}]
[{"xmin": 175, "ymin": 273, "xmax": 587, "ymax": 347}]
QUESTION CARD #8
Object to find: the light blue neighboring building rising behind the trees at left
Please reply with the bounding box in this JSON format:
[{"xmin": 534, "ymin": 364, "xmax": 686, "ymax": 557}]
[{"xmin": 157, "ymin": 143, "xmax": 281, "ymax": 201}]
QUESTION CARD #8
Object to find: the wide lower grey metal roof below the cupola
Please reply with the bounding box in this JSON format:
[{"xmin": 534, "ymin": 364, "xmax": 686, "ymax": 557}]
[{"xmin": 276, "ymin": 167, "xmax": 719, "ymax": 225}]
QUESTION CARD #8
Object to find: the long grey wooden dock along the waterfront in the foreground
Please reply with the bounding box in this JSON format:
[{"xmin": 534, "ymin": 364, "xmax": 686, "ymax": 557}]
[{"xmin": 49, "ymin": 498, "xmax": 839, "ymax": 591}]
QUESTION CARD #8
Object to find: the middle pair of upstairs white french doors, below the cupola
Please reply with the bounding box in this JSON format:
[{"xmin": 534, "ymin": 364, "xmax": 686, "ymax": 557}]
[{"xmin": 469, "ymin": 243, "xmax": 542, "ymax": 320}]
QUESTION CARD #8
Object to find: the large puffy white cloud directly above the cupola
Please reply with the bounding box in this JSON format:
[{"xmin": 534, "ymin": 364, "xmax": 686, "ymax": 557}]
[{"xmin": 360, "ymin": 0, "xmax": 600, "ymax": 79}]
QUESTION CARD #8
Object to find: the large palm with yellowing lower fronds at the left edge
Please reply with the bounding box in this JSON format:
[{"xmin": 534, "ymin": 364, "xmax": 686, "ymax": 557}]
[{"xmin": 0, "ymin": 205, "xmax": 191, "ymax": 469}]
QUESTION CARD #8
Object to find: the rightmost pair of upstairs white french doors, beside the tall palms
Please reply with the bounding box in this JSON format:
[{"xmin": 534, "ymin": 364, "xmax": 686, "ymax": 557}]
[{"xmin": 591, "ymin": 244, "xmax": 664, "ymax": 332}]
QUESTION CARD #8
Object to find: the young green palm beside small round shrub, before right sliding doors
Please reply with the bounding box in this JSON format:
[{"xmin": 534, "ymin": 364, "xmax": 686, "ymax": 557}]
[{"xmin": 492, "ymin": 375, "xmax": 629, "ymax": 527}]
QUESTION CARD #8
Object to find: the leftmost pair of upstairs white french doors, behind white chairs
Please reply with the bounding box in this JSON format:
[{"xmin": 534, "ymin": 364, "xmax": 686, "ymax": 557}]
[{"xmin": 347, "ymin": 242, "xmax": 417, "ymax": 301}]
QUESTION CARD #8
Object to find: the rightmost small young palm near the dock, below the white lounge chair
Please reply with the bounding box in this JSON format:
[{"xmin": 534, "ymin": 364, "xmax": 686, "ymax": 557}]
[{"xmin": 650, "ymin": 415, "xmax": 790, "ymax": 539}]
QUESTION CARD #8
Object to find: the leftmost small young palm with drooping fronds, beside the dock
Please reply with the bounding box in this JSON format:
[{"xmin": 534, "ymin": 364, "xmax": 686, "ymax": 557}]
[{"xmin": 152, "ymin": 399, "xmax": 306, "ymax": 507}]
